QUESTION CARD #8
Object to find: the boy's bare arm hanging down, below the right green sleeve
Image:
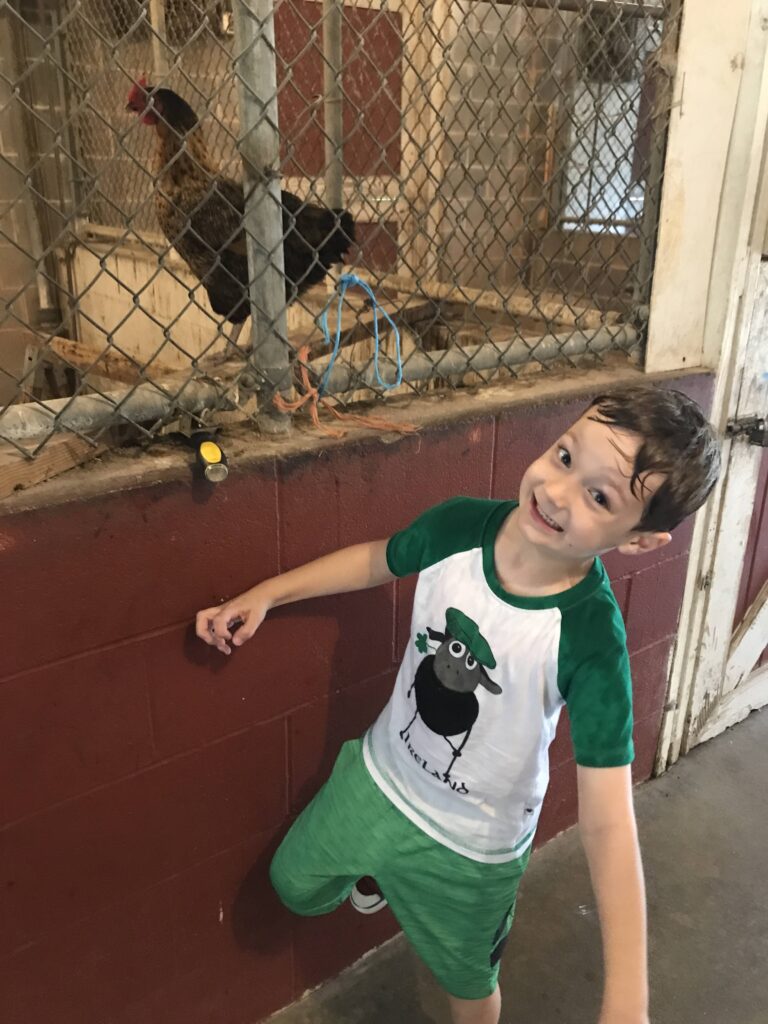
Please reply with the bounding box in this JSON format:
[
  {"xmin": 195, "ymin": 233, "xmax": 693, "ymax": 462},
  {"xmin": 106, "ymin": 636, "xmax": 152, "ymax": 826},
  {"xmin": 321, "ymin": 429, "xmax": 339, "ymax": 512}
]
[{"xmin": 579, "ymin": 765, "xmax": 648, "ymax": 1024}]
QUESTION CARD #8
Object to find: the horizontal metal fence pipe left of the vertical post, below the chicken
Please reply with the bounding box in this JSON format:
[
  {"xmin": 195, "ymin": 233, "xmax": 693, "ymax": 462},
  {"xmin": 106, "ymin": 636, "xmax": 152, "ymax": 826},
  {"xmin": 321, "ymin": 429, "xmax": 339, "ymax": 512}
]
[{"xmin": 0, "ymin": 380, "xmax": 232, "ymax": 442}]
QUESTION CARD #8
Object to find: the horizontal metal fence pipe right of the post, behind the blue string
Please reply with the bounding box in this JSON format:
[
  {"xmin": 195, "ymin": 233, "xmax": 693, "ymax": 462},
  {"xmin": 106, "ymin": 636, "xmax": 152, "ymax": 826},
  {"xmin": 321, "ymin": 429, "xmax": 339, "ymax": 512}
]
[{"xmin": 309, "ymin": 326, "xmax": 638, "ymax": 394}]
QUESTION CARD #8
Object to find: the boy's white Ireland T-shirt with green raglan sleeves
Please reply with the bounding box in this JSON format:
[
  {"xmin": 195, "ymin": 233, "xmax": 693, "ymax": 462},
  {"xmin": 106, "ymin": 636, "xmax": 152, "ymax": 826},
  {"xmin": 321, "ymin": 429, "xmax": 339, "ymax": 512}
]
[{"xmin": 364, "ymin": 498, "xmax": 634, "ymax": 862}]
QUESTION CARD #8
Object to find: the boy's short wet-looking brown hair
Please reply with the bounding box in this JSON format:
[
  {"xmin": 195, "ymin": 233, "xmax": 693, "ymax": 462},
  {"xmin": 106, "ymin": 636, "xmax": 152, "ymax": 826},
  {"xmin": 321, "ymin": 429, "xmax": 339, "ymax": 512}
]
[{"xmin": 587, "ymin": 385, "xmax": 720, "ymax": 532}]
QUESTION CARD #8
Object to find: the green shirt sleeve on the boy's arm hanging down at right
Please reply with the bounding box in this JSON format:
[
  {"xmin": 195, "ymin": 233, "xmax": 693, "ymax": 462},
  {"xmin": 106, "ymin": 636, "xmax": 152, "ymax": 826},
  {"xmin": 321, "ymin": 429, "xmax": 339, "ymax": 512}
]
[{"xmin": 558, "ymin": 582, "xmax": 635, "ymax": 768}]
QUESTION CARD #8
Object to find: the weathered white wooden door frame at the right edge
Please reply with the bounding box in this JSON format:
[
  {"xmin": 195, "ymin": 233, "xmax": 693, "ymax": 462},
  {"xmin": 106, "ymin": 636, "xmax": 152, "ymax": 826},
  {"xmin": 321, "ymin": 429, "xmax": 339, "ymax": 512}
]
[{"xmin": 646, "ymin": 0, "xmax": 768, "ymax": 771}]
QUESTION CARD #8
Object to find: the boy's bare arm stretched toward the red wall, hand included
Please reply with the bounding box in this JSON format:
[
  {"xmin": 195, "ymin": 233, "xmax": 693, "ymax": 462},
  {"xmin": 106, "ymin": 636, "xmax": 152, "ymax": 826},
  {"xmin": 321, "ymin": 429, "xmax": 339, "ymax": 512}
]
[{"xmin": 196, "ymin": 540, "xmax": 394, "ymax": 654}]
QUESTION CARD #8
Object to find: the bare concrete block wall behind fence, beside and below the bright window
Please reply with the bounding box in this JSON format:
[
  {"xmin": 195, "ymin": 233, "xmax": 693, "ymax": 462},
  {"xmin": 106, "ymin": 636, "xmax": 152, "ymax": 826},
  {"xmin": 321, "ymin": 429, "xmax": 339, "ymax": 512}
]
[{"xmin": 440, "ymin": 2, "xmax": 639, "ymax": 308}]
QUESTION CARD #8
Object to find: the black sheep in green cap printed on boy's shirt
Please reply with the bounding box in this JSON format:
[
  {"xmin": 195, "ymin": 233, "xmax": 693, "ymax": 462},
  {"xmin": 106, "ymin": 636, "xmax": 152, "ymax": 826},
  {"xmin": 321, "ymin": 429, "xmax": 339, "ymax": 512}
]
[{"xmin": 400, "ymin": 608, "xmax": 502, "ymax": 782}]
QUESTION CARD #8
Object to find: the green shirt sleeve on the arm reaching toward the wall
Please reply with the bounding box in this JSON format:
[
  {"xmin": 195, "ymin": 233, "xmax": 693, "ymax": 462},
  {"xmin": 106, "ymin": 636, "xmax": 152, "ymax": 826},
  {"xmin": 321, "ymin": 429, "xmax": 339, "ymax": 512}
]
[{"xmin": 387, "ymin": 498, "xmax": 513, "ymax": 577}]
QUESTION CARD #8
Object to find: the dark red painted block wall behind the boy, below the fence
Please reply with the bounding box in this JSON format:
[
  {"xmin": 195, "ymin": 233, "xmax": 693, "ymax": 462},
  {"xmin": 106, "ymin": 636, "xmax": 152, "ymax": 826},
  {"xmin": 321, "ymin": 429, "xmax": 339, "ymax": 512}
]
[{"xmin": 0, "ymin": 378, "xmax": 709, "ymax": 1024}]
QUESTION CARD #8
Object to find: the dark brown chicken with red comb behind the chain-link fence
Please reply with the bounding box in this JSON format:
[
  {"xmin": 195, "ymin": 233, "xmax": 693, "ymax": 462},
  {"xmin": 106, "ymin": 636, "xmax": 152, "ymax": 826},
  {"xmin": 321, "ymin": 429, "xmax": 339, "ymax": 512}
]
[{"xmin": 128, "ymin": 79, "xmax": 354, "ymax": 340}]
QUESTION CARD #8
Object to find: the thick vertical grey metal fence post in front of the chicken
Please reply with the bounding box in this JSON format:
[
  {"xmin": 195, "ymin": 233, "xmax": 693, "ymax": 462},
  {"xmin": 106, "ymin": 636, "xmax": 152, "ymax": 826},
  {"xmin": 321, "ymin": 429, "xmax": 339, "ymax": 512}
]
[{"xmin": 232, "ymin": 0, "xmax": 291, "ymax": 433}]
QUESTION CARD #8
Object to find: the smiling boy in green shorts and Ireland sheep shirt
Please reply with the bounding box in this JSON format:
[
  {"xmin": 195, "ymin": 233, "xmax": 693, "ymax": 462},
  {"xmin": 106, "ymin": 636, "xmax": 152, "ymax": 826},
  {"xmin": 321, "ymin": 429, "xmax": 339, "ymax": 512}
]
[{"xmin": 197, "ymin": 387, "xmax": 719, "ymax": 1024}]
